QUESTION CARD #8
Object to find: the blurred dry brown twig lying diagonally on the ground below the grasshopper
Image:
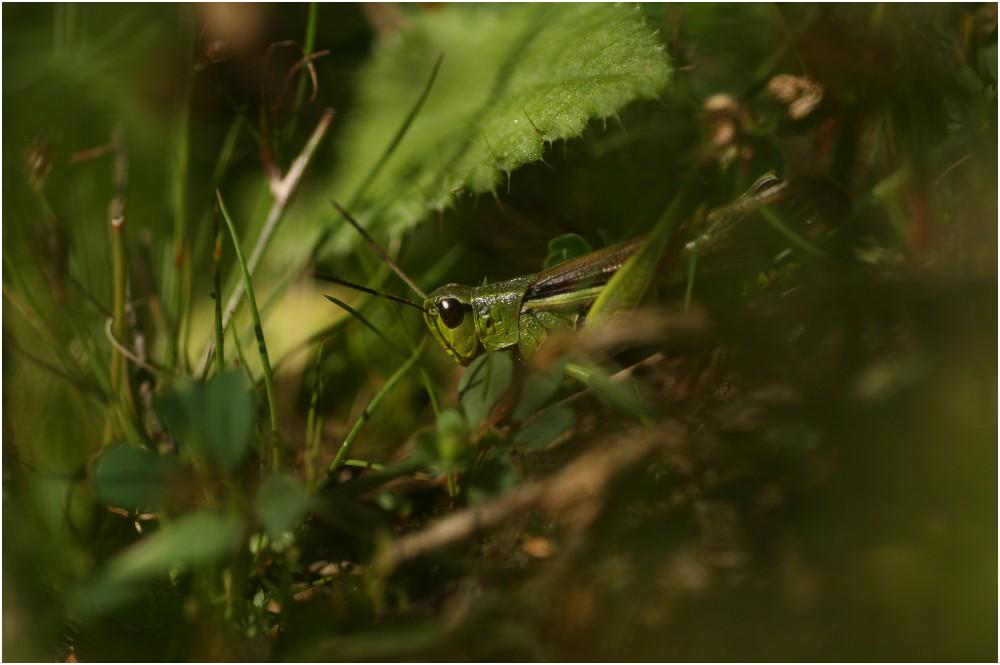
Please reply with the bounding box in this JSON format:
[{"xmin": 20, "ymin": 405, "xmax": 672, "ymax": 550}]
[{"xmin": 376, "ymin": 422, "xmax": 685, "ymax": 575}]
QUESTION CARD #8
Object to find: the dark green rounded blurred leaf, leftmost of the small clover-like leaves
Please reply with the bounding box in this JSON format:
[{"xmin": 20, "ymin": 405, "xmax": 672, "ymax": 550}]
[{"xmin": 92, "ymin": 444, "xmax": 179, "ymax": 511}]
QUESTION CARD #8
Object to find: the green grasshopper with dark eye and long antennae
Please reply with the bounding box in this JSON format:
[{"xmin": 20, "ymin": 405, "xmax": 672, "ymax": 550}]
[{"xmin": 324, "ymin": 173, "xmax": 816, "ymax": 365}]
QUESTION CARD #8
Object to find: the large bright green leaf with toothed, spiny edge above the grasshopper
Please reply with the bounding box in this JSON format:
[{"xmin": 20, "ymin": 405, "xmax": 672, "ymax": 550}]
[{"xmin": 333, "ymin": 4, "xmax": 670, "ymax": 237}]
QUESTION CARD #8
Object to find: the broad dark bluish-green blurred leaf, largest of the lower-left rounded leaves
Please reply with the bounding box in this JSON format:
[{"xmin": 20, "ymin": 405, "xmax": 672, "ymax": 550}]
[{"xmin": 156, "ymin": 371, "xmax": 254, "ymax": 472}]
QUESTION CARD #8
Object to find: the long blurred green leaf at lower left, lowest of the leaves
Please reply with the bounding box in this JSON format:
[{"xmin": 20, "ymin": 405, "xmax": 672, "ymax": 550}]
[{"xmin": 75, "ymin": 511, "xmax": 243, "ymax": 613}]
